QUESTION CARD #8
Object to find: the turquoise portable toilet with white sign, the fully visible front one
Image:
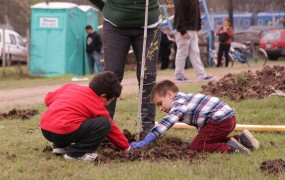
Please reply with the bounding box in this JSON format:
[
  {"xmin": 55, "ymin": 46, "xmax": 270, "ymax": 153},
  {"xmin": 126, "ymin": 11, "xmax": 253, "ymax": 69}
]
[{"xmin": 29, "ymin": 2, "xmax": 85, "ymax": 76}]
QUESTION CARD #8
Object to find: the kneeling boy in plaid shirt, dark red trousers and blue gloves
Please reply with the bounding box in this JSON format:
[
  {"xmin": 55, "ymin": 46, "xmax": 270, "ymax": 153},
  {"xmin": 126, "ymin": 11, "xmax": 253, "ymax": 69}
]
[{"xmin": 131, "ymin": 80, "xmax": 260, "ymax": 154}]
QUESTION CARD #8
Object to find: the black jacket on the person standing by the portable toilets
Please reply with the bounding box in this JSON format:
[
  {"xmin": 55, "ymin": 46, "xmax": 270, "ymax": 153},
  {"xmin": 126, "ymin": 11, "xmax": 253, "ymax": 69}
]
[{"xmin": 86, "ymin": 31, "xmax": 102, "ymax": 54}]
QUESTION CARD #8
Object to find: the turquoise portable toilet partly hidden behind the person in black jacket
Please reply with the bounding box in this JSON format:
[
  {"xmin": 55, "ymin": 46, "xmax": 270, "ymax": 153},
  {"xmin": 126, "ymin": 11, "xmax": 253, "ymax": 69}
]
[{"xmin": 79, "ymin": 5, "xmax": 99, "ymax": 74}]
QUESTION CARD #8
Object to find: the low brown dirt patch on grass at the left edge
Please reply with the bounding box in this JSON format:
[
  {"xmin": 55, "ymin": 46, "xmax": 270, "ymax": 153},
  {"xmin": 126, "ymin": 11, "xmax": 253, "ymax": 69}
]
[{"xmin": 0, "ymin": 109, "xmax": 39, "ymax": 120}]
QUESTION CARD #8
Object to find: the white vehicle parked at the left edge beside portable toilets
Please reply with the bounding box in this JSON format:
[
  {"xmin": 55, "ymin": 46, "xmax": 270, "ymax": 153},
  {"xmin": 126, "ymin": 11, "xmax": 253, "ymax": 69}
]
[{"xmin": 0, "ymin": 29, "xmax": 27, "ymax": 66}]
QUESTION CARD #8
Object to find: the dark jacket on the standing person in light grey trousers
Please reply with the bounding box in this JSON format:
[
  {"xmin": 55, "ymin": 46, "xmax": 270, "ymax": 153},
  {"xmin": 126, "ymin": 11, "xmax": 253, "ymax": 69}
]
[{"xmin": 174, "ymin": 0, "xmax": 201, "ymax": 35}]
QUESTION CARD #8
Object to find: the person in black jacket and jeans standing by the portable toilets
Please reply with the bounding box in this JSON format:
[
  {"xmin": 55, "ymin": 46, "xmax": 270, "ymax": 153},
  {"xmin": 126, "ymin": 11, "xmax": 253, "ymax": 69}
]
[{"xmin": 85, "ymin": 25, "xmax": 104, "ymax": 74}]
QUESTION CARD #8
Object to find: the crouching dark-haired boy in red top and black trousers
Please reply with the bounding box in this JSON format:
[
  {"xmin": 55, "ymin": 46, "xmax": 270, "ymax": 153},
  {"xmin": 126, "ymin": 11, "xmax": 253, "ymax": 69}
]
[{"xmin": 40, "ymin": 71, "xmax": 130, "ymax": 161}]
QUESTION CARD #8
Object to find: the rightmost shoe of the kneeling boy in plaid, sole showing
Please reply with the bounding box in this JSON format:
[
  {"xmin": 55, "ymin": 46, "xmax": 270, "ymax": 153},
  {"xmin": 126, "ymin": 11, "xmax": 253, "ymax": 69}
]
[{"xmin": 239, "ymin": 130, "xmax": 260, "ymax": 150}]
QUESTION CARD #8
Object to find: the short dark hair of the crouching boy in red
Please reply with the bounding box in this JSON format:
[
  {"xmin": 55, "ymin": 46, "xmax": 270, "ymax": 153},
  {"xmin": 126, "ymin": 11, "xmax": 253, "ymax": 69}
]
[{"xmin": 89, "ymin": 71, "xmax": 122, "ymax": 100}]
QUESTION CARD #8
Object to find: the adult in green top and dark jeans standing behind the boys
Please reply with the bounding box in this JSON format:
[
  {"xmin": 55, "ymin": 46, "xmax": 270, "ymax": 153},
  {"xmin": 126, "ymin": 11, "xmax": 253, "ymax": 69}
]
[{"xmin": 87, "ymin": 0, "xmax": 161, "ymax": 131}]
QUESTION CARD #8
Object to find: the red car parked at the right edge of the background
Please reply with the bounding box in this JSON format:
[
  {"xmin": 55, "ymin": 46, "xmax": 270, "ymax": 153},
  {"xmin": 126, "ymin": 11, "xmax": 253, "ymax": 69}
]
[{"xmin": 260, "ymin": 29, "xmax": 285, "ymax": 60}]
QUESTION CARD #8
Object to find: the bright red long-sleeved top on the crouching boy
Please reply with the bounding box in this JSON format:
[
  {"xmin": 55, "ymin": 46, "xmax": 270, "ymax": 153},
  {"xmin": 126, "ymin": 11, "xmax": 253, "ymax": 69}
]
[{"xmin": 40, "ymin": 84, "xmax": 130, "ymax": 150}]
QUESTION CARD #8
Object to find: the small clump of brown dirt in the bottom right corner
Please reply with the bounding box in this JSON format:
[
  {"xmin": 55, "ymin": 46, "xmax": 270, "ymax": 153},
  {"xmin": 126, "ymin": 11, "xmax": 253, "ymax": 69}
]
[{"xmin": 260, "ymin": 159, "xmax": 285, "ymax": 174}]
